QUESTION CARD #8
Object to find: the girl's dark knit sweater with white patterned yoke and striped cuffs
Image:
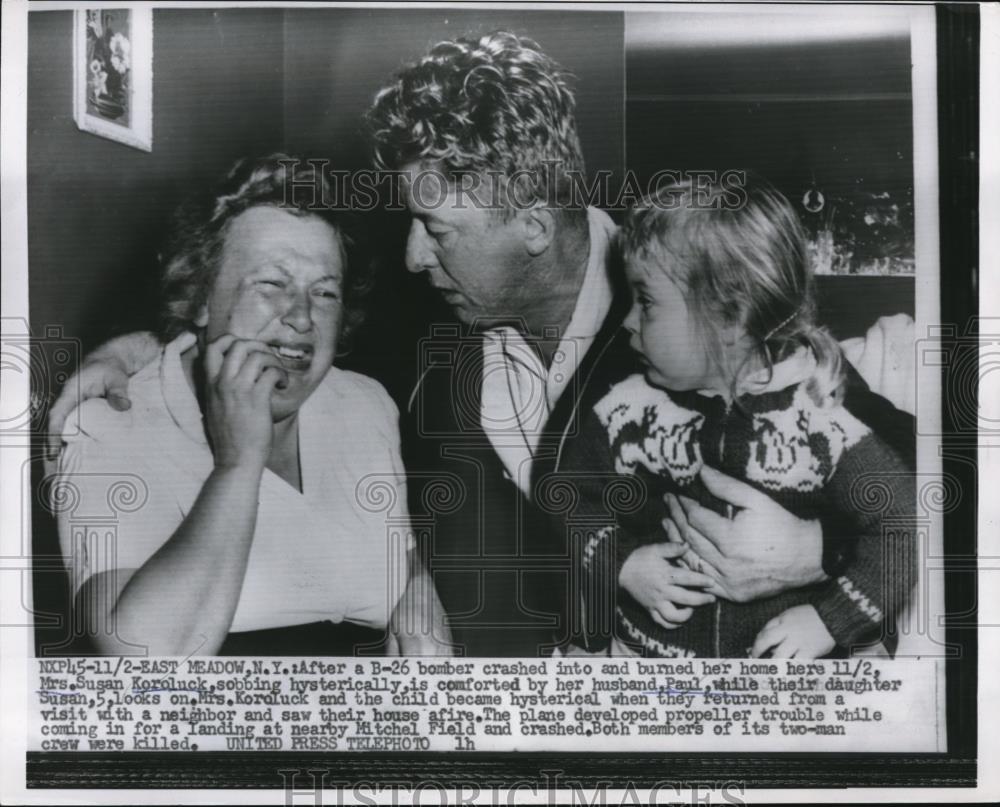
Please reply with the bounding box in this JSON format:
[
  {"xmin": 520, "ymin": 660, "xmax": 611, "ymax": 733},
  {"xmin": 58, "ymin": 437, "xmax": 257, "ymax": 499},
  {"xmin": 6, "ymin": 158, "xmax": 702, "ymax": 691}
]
[{"xmin": 571, "ymin": 365, "xmax": 916, "ymax": 657}]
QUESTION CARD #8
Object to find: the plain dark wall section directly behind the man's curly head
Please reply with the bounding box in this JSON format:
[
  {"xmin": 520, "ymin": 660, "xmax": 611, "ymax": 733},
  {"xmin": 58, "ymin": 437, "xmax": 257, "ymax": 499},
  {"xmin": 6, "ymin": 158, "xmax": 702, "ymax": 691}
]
[{"xmin": 285, "ymin": 8, "xmax": 625, "ymax": 188}]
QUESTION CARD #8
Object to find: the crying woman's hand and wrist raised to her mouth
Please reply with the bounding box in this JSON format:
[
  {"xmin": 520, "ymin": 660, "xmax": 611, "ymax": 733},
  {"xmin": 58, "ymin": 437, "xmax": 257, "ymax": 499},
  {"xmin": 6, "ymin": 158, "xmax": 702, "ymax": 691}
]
[{"xmin": 205, "ymin": 334, "xmax": 288, "ymax": 470}]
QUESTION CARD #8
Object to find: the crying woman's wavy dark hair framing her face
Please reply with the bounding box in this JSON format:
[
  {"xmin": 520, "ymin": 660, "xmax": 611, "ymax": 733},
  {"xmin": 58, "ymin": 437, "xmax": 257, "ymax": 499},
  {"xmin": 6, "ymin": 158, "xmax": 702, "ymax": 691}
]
[{"xmin": 159, "ymin": 153, "xmax": 372, "ymax": 346}]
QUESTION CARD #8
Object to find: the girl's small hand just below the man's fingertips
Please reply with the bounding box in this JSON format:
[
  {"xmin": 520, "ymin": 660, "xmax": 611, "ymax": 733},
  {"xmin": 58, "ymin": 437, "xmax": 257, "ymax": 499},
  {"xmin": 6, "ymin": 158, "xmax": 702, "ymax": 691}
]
[{"xmin": 618, "ymin": 544, "xmax": 715, "ymax": 630}]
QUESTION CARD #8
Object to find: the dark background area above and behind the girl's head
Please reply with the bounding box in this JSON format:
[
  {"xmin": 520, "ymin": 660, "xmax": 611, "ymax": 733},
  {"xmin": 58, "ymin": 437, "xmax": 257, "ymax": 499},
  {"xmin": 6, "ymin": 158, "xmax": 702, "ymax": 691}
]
[{"xmin": 625, "ymin": 28, "xmax": 914, "ymax": 338}]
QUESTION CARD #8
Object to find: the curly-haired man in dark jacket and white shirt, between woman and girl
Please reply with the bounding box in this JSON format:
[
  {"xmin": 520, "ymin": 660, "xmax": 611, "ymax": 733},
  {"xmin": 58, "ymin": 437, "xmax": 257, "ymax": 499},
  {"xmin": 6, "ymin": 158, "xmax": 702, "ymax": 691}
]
[{"xmin": 53, "ymin": 33, "xmax": 916, "ymax": 656}]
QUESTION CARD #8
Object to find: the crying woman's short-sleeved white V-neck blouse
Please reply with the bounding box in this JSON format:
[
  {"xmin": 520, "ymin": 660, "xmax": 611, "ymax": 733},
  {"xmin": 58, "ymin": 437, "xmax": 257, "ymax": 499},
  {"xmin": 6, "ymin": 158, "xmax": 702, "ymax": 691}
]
[{"xmin": 52, "ymin": 334, "xmax": 413, "ymax": 631}]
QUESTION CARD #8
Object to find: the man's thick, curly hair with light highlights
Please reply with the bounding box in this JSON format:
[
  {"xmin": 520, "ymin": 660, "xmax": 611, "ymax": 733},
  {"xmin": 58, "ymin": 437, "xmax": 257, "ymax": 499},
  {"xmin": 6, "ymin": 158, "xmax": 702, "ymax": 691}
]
[{"xmin": 366, "ymin": 31, "xmax": 584, "ymax": 223}]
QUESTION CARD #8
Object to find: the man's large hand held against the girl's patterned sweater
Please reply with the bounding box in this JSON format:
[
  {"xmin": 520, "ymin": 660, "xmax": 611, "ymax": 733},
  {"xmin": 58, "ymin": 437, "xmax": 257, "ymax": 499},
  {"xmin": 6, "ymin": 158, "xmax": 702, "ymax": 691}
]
[{"xmin": 663, "ymin": 466, "xmax": 826, "ymax": 602}]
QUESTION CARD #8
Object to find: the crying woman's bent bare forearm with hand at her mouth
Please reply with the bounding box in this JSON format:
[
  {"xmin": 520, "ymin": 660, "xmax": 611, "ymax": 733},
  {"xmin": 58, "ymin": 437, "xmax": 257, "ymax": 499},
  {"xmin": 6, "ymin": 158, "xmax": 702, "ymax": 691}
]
[{"xmin": 93, "ymin": 334, "xmax": 287, "ymax": 655}]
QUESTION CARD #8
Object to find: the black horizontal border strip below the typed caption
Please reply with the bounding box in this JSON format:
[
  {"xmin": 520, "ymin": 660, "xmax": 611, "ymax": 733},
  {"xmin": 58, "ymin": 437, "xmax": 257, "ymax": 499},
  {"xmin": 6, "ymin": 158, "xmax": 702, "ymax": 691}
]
[{"xmin": 28, "ymin": 751, "xmax": 976, "ymax": 792}]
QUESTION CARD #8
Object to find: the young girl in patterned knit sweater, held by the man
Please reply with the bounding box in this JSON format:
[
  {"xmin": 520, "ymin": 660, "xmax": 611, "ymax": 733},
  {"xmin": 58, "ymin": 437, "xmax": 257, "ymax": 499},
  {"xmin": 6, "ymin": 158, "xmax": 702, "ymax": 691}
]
[{"xmin": 583, "ymin": 177, "xmax": 915, "ymax": 658}]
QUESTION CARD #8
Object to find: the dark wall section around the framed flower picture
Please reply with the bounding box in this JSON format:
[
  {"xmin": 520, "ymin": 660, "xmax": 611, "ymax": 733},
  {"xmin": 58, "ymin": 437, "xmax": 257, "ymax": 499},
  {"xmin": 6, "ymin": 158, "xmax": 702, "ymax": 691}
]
[{"xmin": 28, "ymin": 9, "xmax": 284, "ymax": 350}]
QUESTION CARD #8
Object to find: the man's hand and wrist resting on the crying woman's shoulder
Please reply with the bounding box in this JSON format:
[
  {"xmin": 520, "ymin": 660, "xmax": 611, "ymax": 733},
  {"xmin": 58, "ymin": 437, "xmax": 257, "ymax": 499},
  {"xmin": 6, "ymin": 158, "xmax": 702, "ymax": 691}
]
[{"xmin": 46, "ymin": 331, "xmax": 160, "ymax": 460}]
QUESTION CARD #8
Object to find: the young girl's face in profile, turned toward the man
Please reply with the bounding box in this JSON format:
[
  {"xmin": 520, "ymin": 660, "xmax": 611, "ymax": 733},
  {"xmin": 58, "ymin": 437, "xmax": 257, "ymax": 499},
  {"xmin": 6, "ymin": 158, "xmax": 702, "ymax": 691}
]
[{"xmin": 624, "ymin": 251, "xmax": 729, "ymax": 392}]
